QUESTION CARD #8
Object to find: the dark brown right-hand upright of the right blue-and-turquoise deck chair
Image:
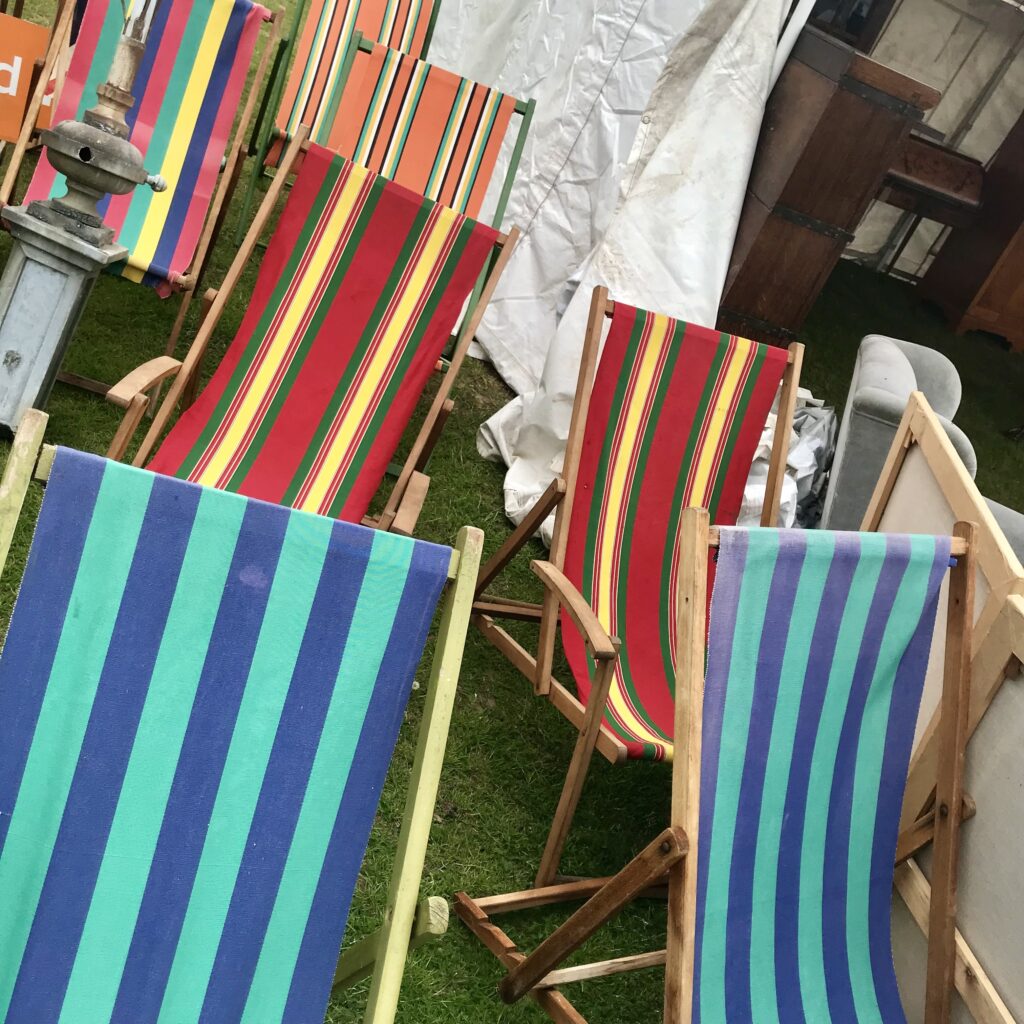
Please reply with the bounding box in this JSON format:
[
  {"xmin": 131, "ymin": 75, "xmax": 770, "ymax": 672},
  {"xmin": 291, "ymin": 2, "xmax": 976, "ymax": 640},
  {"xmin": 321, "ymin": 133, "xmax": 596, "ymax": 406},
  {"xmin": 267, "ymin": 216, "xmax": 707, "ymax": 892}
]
[{"xmin": 925, "ymin": 522, "xmax": 978, "ymax": 1024}]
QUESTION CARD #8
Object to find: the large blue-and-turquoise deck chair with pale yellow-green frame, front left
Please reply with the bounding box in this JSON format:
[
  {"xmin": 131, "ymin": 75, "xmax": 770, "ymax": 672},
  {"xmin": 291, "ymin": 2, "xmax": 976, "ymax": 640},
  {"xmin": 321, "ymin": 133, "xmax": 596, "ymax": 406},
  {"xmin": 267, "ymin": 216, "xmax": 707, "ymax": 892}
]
[{"xmin": 0, "ymin": 412, "xmax": 482, "ymax": 1024}]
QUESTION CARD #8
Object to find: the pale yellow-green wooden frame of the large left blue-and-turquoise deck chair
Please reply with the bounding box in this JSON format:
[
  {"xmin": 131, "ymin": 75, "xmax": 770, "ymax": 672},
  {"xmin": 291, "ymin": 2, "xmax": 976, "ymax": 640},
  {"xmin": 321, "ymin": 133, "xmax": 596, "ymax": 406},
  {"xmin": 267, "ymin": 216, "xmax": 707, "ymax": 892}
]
[{"xmin": 0, "ymin": 410, "xmax": 483, "ymax": 1024}]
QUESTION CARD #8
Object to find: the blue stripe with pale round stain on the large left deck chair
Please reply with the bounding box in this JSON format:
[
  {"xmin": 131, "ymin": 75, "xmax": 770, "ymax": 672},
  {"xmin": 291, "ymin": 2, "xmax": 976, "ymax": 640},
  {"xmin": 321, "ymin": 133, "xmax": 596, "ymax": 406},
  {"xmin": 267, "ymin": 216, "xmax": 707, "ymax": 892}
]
[{"xmin": 111, "ymin": 502, "xmax": 289, "ymax": 1024}]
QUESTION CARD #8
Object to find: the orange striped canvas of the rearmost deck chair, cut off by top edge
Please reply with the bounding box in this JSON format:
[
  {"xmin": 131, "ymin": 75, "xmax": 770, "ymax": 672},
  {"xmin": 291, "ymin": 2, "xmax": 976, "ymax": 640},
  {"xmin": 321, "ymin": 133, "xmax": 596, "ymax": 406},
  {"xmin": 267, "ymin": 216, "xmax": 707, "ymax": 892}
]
[{"xmin": 278, "ymin": 0, "xmax": 434, "ymax": 148}]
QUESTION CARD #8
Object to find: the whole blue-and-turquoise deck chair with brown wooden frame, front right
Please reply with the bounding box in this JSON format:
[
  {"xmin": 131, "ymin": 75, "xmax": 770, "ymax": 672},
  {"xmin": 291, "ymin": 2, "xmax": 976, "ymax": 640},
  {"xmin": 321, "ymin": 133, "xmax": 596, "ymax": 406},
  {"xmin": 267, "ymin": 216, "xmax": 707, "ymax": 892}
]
[{"xmin": 457, "ymin": 509, "xmax": 977, "ymax": 1024}]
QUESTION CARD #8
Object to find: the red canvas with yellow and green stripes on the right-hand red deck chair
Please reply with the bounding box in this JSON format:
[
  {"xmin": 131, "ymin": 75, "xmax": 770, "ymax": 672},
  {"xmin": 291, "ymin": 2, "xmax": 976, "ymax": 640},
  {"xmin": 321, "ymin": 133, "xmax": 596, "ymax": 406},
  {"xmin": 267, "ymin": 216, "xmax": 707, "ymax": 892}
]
[{"xmin": 562, "ymin": 302, "xmax": 787, "ymax": 760}]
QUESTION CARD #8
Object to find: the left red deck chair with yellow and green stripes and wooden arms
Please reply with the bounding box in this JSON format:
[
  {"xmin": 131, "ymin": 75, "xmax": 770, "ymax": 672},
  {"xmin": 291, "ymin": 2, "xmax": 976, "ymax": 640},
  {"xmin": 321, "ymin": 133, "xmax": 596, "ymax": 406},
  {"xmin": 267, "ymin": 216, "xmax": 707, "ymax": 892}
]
[{"xmin": 109, "ymin": 133, "xmax": 514, "ymax": 531}]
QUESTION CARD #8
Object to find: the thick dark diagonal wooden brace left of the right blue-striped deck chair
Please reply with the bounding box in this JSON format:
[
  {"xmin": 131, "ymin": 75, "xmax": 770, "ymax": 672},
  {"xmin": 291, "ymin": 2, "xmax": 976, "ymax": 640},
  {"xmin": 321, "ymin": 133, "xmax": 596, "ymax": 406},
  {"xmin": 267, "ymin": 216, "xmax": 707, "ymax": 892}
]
[{"xmin": 499, "ymin": 828, "xmax": 687, "ymax": 1002}]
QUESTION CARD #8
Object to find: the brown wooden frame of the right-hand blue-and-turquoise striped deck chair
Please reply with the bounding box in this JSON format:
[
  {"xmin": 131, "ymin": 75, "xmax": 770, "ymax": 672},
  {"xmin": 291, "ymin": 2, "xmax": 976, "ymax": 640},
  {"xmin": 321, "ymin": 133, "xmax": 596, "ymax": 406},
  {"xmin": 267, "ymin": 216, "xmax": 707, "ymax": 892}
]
[{"xmin": 456, "ymin": 509, "xmax": 976, "ymax": 1024}]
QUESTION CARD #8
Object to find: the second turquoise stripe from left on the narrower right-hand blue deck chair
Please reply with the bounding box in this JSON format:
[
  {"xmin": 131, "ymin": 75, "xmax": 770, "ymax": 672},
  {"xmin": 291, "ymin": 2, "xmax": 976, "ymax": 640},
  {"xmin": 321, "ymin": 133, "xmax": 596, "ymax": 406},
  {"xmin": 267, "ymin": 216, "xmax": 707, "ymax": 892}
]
[{"xmin": 751, "ymin": 534, "xmax": 836, "ymax": 1024}]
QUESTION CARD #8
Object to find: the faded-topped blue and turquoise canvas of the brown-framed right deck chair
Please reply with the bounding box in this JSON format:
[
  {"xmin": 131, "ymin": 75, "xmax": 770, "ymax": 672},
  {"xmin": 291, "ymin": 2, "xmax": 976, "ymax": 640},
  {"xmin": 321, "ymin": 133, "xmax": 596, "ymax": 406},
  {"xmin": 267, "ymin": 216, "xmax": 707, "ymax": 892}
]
[{"xmin": 693, "ymin": 529, "xmax": 949, "ymax": 1024}]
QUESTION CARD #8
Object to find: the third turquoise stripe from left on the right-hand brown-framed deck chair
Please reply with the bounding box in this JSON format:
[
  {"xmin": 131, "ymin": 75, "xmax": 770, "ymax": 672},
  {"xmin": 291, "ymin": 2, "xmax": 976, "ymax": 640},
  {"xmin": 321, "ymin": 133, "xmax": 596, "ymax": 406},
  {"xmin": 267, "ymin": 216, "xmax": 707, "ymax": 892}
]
[{"xmin": 797, "ymin": 534, "xmax": 886, "ymax": 1007}]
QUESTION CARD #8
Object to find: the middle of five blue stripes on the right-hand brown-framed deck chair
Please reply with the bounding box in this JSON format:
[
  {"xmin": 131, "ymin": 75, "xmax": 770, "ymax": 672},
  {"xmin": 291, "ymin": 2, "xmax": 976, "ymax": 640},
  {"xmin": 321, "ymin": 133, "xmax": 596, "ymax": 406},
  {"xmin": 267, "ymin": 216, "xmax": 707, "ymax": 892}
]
[{"xmin": 775, "ymin": 548, "xmax": 859, "ymax": 1024}]
